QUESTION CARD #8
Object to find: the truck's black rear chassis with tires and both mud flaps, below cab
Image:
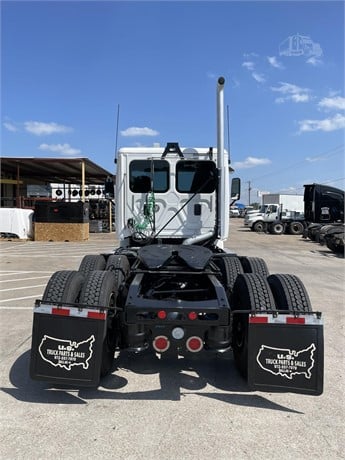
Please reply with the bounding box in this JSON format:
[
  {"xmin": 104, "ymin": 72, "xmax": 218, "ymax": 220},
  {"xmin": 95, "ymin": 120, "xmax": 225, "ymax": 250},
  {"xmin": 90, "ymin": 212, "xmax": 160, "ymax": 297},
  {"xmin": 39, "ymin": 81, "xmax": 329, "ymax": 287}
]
[{"xmin": 31, "ymin": 245, "xmax": 323, "ymax": 395}]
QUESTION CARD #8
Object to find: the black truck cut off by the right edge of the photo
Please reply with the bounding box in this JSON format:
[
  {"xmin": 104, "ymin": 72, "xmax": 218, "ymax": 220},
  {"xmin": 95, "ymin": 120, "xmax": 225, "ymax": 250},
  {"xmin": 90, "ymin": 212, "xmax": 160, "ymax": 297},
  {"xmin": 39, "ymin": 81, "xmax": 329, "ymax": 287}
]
[{"xmin": 303, "ymin": 184, "xmax": 345, "ymax": 254}]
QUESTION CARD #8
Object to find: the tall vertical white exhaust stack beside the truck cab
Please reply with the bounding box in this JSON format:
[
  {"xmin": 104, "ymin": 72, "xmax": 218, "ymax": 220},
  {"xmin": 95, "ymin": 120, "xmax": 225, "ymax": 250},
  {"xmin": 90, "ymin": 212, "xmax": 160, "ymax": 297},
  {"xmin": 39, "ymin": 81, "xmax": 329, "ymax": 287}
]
[{"xmin": 217, "ymin": 77, "xmax": 229, "ymax": 240}]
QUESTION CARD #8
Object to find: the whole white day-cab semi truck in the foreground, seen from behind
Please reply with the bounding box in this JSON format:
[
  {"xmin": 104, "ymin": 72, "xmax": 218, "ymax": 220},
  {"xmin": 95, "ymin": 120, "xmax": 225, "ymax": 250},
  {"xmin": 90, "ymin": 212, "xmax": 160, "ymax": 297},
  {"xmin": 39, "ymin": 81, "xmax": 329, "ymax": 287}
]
[{"xmin": 30, "ymin": 77, "xmax": 323, "ymax": 395}]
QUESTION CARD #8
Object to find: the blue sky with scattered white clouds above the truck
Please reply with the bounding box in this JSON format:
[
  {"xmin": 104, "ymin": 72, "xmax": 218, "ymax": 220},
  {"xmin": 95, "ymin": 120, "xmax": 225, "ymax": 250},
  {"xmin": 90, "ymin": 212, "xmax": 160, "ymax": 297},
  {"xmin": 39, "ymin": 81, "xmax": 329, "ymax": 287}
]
[{"xmin": 1, "ymin": 1, "xmax": 345, "ymax": 202}]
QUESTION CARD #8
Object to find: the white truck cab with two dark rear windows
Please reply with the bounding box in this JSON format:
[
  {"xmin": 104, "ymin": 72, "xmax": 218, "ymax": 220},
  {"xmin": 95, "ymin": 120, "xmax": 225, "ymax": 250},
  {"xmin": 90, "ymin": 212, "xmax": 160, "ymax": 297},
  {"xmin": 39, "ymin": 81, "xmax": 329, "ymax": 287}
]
[{"xmin": 116, "ymin": 143, "xmax": 229, "ymax": 247}]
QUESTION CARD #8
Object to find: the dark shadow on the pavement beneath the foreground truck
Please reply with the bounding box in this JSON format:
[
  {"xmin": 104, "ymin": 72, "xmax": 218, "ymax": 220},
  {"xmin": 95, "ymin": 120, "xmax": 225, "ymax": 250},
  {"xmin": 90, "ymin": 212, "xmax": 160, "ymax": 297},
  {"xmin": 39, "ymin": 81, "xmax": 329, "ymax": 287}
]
[{"xmin": 1, "ymin": 351, "xmax": 301, "ymax": 413}]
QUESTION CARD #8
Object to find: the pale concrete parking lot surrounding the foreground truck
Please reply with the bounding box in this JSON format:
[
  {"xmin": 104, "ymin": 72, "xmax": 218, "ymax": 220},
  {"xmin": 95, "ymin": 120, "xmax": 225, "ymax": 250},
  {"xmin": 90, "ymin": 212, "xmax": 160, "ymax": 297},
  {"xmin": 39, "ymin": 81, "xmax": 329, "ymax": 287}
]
[{"xmin": 0, "ymin": 218, "xmax": 345, "ymax": 460}]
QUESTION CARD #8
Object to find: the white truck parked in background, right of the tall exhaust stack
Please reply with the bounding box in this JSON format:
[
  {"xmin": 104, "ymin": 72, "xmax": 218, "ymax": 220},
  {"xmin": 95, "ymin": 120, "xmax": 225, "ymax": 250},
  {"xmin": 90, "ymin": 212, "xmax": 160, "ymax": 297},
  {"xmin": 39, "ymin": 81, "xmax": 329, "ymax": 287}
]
[{"xmin": 244, "ymin": 193, "xmax": 305, "ymax": 235}]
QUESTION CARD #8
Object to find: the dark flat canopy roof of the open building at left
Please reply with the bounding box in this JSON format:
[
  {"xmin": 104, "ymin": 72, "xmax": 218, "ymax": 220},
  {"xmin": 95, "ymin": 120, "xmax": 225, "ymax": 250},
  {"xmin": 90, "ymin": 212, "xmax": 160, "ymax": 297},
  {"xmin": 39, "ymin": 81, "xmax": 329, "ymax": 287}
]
[{"xmin": 1, "ymin": 157, "xmax": 114, "ymax": 184}]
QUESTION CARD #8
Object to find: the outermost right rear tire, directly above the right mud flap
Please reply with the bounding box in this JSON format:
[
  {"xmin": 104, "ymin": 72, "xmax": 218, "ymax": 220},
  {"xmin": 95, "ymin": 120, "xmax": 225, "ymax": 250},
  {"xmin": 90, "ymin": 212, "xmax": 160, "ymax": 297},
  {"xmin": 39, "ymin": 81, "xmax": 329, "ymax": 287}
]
[{"xmin": 267, "ymin": 274, "xmax": 312, "ymax": 312}]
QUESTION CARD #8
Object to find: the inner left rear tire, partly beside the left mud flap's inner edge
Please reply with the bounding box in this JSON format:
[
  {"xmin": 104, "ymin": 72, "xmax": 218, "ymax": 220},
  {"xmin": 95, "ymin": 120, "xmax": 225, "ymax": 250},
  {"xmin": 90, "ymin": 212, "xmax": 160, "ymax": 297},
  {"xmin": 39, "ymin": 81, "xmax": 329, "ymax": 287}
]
[{"xmin": 80, "ymin": 270, "xmax": 117, "ymax": 377}]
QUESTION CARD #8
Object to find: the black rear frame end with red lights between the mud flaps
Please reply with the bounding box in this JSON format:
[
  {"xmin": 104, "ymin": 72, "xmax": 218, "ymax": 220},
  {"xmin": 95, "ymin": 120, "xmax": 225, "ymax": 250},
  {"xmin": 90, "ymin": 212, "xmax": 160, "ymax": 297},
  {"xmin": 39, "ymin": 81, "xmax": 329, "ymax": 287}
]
[{"xmin": 122, "ymin": 274, "xmax": 231, "ymax": 349}]
